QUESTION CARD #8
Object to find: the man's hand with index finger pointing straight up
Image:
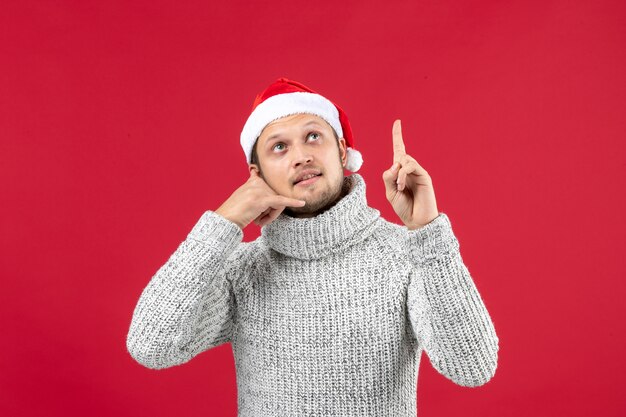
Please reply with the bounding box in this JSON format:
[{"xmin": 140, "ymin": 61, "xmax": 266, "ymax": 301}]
[{"xmin": 383, "ymin": 120, "xmax": 439, "ymax": 230}]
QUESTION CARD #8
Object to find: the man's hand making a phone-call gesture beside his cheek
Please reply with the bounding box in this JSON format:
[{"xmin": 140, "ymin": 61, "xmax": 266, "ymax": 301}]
[{"xmin": 215, "ymin": 169, "xmax": 305, "ymax": 230}]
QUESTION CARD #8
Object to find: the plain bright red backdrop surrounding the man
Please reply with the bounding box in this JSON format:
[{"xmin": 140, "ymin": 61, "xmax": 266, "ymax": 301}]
[{"xmin": 0, "ymin": 0, "xmax": 626, "ymax": 417}]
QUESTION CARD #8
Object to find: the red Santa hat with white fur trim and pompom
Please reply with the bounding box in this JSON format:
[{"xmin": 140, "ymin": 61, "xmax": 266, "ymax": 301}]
[{"xmin": 241, "ymin": 78, "xmax": 363, "ymax": 172}]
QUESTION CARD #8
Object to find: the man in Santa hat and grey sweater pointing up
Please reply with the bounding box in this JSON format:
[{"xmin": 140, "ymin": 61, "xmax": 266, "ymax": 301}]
[{"xmin": 127, "ymin": 78, "xmax": 499, "ymax": 417}]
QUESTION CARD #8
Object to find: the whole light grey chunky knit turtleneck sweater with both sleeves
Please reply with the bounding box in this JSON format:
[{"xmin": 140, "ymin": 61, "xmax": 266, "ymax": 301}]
[{"xmin": 126, "ymin": 174, "xmax": 498, "ymax": 417}]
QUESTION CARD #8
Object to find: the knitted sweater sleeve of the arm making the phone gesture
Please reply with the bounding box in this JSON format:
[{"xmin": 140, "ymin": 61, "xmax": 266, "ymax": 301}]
[{"xmin": 126, "ymin": 210, "xmax": 245, "ymax": 369}]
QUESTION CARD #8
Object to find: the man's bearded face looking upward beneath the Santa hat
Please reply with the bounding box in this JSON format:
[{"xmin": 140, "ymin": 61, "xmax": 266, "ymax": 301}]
[{"xmin": 249, "ymin": 114, "xmax": 347, "ymax": 217}]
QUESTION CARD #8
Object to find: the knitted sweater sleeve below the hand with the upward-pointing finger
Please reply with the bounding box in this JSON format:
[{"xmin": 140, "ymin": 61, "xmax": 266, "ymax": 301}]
[{"xmin": 406, "ymin": 212, "xmax": 499, "ymax": 387}]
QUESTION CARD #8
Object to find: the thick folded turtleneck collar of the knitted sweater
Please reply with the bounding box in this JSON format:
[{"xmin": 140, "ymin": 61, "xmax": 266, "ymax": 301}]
[{"xmin": 261, "ymin": 173, "xmax": 380, "ymax": 259}]
